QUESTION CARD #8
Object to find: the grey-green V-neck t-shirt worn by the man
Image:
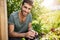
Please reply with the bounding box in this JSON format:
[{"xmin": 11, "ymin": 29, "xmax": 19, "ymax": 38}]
[{"xmin": 8, "ymin": 11, "xmax": 32, "ymax": 40}]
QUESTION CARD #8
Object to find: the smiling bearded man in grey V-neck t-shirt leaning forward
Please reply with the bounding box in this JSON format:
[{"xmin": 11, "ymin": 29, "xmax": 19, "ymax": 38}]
[{"xmin": 8, "ymin": 0, "xmax": 36, "ymax": 40}]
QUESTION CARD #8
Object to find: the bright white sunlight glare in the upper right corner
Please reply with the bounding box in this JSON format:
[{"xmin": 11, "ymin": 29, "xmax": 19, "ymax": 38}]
[{"xmin": 41, "ymin": 0, "xmax": 60, "ymax": 10}]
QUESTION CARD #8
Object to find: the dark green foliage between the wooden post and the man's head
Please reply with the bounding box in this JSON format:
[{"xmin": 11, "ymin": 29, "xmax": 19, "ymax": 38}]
[{"xmin": 7, "ymin": 0, "xmax": 22, "ymax": 16}]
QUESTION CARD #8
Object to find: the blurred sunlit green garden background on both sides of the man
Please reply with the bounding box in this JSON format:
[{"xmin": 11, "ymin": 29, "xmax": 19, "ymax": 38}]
[{"xmin": 7, "ymin": 0, "xmax": 60, "ymax": 40}]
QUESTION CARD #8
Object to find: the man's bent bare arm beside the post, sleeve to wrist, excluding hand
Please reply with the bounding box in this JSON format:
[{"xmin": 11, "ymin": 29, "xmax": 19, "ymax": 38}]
[{"xmin": 8, "ymin": 24, "xmax": 26, "ymax": 37}]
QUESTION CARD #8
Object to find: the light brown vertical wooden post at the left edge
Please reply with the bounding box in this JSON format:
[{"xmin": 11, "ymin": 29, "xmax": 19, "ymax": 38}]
[{"xmin": 0, "ymin": 0, "xmax": 8, "ymax": 40}]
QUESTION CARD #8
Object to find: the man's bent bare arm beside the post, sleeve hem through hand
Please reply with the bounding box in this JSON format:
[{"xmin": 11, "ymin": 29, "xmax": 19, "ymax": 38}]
[{"xmin": 9, "ymin": 24, "xmax": 34, "ymax": 39}]
